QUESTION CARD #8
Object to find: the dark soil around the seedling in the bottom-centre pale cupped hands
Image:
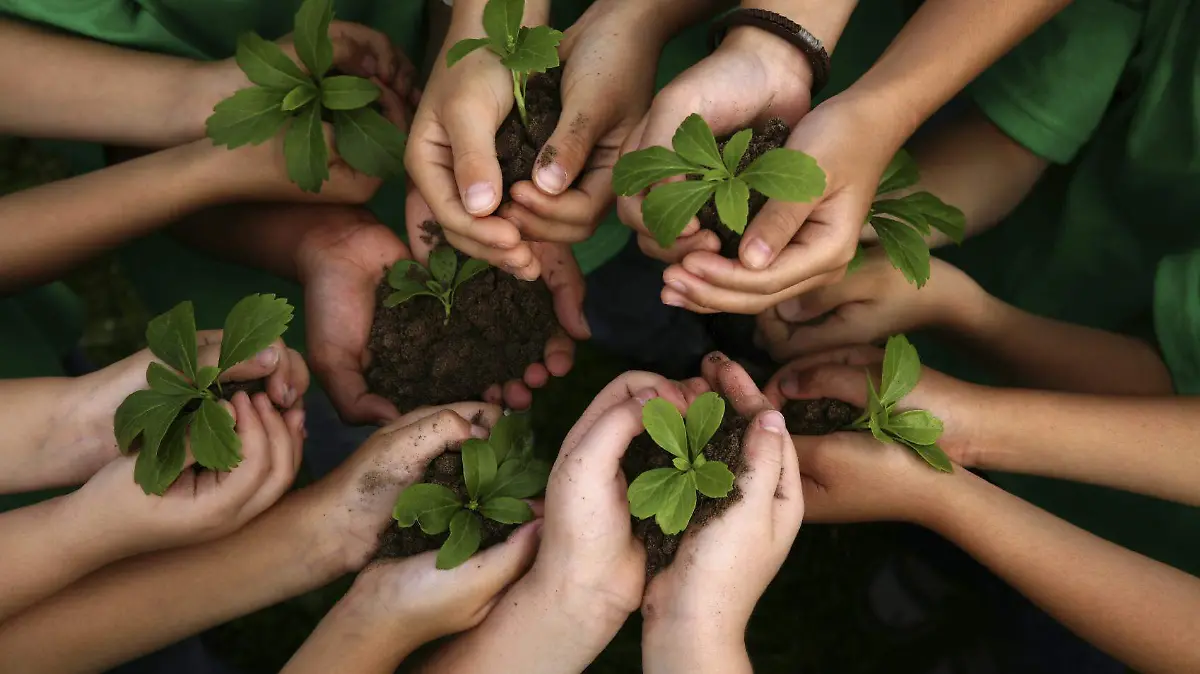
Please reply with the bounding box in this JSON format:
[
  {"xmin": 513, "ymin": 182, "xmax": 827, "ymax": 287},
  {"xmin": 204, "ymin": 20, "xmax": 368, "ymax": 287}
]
[{"xmin": 622, "ymin": 414, "xmax": 749, "ymax": 578}]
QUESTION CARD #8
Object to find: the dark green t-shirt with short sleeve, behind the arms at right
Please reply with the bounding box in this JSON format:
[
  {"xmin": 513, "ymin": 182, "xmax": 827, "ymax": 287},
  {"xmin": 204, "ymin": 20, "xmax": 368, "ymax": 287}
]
[{"xmin": 923, "ymin": 0, "xmax": 1200, "ymax": 573}]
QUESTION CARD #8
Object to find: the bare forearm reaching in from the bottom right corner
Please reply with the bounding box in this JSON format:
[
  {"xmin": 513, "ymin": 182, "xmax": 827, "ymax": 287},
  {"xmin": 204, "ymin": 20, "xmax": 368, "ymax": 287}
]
[{"xmin": 935, "ymin": 471, "xmax": 1200, "ymax": 674}]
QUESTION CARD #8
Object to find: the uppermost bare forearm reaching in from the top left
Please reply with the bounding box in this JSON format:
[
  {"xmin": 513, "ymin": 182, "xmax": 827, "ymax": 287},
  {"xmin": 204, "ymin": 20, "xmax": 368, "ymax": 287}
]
[{"xmin": 0, "ymin": 19, "xmax": 206, "ymax": 148}]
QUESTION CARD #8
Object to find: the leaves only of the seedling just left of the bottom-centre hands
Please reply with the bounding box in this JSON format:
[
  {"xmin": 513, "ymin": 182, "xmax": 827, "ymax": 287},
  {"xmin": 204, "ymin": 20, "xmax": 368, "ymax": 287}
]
[{"xmin": 392, "ymin": 415, "xmax": 550, "ymax": 570}]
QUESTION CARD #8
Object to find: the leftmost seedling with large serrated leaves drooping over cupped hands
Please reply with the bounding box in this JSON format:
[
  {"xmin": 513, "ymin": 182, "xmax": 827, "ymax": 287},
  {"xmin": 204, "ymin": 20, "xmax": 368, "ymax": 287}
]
[{"xmin": 113, "ymin": 295, "xmax": 292, "ymax": 495}]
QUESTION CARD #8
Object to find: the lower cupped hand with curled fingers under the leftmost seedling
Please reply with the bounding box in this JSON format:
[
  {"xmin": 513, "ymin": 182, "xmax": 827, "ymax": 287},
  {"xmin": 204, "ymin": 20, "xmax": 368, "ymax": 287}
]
[{"xmin": 67, "ymin": 392, "xmax": 304, "ymax": 556}]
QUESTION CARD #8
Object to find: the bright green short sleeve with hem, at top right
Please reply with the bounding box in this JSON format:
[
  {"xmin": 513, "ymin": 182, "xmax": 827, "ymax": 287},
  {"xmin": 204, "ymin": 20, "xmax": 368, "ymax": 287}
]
[{"xmin": 970, "ymin": 0, "xmax": 1142, "ymax": 164}]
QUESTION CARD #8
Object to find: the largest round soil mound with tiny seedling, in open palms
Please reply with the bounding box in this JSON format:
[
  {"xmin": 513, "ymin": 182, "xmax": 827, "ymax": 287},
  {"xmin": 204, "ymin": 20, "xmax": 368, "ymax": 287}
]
[{"xmin": 367, "ymin": 238, "xmax": 558, "ymax": 411}]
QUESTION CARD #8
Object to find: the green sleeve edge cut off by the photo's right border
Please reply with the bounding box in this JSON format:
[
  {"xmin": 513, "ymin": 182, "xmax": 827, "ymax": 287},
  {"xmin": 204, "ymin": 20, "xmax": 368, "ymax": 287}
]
[{"xmin": 1154, "ymin": 251, "xmax": 1200, "ymax": 396}]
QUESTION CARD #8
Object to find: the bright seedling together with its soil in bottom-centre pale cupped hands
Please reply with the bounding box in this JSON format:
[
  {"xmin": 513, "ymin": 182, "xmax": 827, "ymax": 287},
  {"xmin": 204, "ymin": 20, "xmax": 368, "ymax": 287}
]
[{"xmin": 622, "ymin": 393, "xmax": 746, "ymax": 574}]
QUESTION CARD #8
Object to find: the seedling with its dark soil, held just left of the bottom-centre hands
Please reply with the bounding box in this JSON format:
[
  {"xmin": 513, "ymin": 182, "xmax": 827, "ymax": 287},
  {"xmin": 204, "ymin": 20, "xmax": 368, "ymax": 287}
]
[{"xmin": 379, "ymin": 415, "xmax": 550, "ymax": 568}]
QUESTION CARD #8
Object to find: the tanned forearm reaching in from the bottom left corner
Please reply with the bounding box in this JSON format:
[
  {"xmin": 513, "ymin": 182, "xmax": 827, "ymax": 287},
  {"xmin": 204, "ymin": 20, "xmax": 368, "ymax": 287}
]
[{"xmin": 0, "ymin": 488, "xmax": 348, "ymax": 673}]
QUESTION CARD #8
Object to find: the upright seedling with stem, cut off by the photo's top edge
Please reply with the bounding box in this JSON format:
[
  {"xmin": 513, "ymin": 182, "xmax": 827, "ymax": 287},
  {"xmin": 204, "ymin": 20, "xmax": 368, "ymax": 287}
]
[{"xmin": 446, "ymin": 0, "xmax": 563, "ymax": 128}]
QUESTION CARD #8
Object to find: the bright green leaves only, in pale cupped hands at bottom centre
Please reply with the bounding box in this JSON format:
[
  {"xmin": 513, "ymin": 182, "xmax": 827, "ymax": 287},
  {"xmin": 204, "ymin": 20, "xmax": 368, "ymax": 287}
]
[{"xmin": 626, "ymin": 392, "xmax": 733, "ymax": 535}]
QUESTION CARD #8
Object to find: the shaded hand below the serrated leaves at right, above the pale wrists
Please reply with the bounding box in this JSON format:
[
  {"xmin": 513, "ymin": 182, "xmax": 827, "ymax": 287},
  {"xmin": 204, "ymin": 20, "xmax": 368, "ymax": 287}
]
[{"xmin": 758, "ymin": 248, "xmax": 984, "ymax": 362}]
